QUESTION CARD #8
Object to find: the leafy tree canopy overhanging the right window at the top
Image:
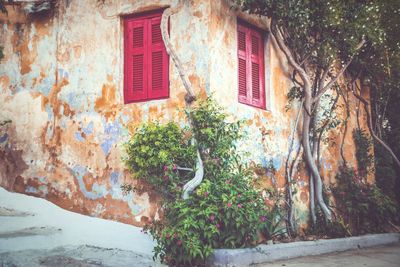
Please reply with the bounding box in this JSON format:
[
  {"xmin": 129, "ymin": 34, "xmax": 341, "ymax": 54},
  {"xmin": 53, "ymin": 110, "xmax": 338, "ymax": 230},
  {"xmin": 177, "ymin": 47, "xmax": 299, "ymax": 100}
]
[{"xmin": 236, "ymin": 0, "xmax": 385, "ymax": 72}]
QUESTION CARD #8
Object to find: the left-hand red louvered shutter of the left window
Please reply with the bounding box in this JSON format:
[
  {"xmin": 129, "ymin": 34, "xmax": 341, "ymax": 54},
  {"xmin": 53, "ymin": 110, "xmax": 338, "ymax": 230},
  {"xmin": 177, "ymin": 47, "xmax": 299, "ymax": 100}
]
[{"xmin": 124, "ymin": 19, "xmax": 147, "ymax": 103}]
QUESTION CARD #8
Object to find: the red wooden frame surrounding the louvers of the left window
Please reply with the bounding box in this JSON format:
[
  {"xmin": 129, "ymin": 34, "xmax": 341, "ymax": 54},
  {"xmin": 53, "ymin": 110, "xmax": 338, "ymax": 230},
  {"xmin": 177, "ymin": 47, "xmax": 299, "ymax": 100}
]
[{"xmin": 122, "ymin": 8, "xmax": 170, "ymax": 104}]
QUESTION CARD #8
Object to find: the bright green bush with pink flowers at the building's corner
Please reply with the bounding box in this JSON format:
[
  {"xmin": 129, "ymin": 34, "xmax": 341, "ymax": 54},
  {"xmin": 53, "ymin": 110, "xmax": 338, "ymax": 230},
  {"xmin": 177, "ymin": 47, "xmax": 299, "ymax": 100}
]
[{"xmin": 125, "ymin": 98, "xmax": 276, "ymax": 266}]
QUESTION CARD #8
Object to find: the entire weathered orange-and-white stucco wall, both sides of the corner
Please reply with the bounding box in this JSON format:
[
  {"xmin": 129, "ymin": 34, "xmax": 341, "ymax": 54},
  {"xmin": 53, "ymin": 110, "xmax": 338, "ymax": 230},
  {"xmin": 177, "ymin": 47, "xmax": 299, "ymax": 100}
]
[{"xmin": 0, "ymin": 0, "xmax": 368, "ymax": 230}]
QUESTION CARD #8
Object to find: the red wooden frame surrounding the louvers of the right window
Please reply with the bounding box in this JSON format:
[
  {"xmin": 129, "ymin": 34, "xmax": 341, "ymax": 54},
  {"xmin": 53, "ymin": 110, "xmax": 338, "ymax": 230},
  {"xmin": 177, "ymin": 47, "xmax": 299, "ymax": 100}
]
[{"xmin": 236, "ymin": 18, "xmax": 267, "ymax": 110}]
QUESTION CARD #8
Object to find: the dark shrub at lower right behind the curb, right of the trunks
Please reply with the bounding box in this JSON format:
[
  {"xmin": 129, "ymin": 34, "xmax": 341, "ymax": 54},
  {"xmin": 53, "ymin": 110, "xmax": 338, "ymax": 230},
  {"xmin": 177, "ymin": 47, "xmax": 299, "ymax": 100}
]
[{"xmin": 332, "ymin": 167, "xmax": 396, "ymax": 235}]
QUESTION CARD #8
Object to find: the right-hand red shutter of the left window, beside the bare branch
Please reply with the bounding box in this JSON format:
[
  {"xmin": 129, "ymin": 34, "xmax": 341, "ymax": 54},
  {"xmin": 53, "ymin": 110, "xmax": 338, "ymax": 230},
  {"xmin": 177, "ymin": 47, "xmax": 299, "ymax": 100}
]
[{"xmin": 148, "ymin": 17, "xmax": 169, "ymax": 99}]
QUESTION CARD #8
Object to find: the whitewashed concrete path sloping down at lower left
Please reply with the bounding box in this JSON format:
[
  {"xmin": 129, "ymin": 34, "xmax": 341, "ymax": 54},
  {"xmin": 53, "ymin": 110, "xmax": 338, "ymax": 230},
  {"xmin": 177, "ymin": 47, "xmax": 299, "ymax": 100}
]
[{"xmin": 0, "ymin": 187, "xmax": 161, "ymax": 267}]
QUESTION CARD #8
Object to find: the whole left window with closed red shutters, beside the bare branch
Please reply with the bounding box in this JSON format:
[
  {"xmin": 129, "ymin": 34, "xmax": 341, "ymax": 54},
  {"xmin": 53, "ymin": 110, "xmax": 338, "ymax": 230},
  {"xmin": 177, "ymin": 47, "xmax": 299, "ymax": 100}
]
[{"xmin": 124, "ymin": 12, "xmax": 169, "ymax": 103}]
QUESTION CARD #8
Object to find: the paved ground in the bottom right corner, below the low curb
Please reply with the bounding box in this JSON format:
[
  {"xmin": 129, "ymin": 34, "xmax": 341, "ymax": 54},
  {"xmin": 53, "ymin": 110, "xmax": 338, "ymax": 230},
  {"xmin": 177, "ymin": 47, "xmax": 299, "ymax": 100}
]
[{"xmin": 254, "ymin": 243, "xmax": 400, "ymax": 267}]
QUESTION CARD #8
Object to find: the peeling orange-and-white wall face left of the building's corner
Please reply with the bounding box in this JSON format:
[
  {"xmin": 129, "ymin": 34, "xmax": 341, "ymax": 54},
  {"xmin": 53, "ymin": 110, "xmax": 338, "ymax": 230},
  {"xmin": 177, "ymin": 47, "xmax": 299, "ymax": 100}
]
[{"xmin": 0, "ymin": 0, "xmax": 210, "ymax": 225}]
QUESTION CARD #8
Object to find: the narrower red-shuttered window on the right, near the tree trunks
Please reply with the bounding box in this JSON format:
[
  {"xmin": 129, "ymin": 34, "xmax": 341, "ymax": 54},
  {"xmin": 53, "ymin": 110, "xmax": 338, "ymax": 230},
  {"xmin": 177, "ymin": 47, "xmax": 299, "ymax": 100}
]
[{"xmin": 237, "ymin": 21, "xmax": 265, "ymax": 108}]
